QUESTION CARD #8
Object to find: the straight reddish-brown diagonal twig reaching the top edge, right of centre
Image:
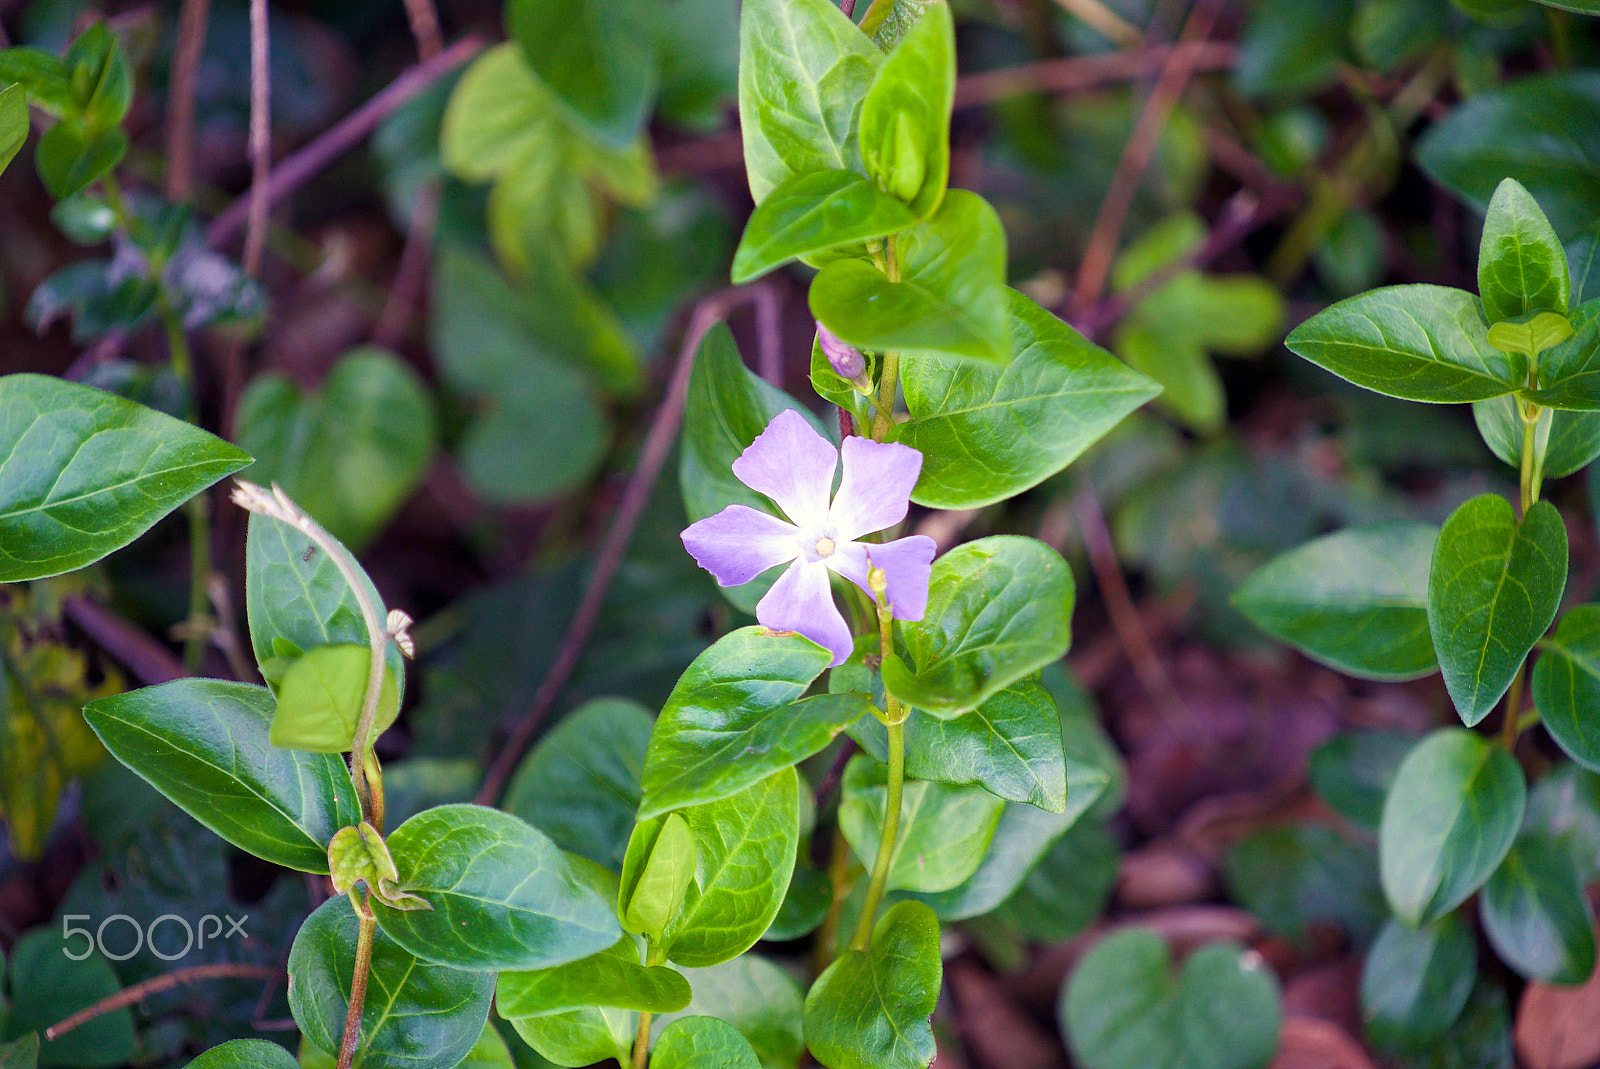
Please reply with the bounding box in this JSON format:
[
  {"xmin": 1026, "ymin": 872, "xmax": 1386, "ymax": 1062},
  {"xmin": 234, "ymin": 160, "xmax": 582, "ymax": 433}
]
[{"xmin": 1070, "ymin": 0, "xmax": 1218, "ymax": 317}]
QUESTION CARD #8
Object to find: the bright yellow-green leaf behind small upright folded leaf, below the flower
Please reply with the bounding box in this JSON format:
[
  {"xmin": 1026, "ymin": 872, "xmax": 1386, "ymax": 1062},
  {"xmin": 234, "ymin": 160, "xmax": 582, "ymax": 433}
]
[{"xmin": 661, "ymin": 768, "xmax": 800, "ymax": 968}]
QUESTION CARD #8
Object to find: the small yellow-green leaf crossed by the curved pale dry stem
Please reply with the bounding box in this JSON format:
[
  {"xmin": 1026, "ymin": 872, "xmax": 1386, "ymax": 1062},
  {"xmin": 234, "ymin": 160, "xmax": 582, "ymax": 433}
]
[{"xmin": 269, "ymin": 643, "xmax": 400, "ymax": 754}]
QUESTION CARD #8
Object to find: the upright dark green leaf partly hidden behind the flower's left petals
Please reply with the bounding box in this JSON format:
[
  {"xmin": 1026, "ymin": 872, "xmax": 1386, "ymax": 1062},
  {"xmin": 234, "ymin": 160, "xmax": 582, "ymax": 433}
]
[{"xmin": 678, "ymin": 323, "xmax": 825, "ymax": 615}]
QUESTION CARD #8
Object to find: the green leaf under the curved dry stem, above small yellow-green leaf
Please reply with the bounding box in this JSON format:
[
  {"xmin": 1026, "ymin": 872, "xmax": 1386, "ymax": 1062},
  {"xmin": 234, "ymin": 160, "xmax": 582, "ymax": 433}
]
[{"xmin": 245, "ymin": 512, "xmax": 405, "ymax": 695}]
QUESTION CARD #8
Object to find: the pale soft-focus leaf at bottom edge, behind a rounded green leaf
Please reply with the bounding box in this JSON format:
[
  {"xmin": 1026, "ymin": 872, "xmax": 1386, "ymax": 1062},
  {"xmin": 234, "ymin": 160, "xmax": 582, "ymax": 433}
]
[{"xmin": 654, "ymin": 954, "xmax": 803, "ymax": 1069}]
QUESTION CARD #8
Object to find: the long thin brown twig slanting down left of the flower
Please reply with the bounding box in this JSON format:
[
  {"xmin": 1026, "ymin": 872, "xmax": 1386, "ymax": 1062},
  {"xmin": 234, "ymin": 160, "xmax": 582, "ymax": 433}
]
[{"xmin": 475, "ymin": 286, "xmax": 758, "ymax": 805}]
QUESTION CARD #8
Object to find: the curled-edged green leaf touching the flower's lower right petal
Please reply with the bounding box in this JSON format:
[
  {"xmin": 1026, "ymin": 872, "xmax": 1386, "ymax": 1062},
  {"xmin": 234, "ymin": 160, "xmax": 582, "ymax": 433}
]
[{"xmin": 883, "ymin": 535, "xmax": 1074, "ymax": 719}]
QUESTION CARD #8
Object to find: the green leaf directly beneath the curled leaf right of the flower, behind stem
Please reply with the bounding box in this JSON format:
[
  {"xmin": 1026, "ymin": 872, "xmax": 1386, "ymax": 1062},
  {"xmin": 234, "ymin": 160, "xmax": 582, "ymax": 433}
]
[{"xmin": 850, "ymin": 680, "xmax": 1081, "ymax": 813}]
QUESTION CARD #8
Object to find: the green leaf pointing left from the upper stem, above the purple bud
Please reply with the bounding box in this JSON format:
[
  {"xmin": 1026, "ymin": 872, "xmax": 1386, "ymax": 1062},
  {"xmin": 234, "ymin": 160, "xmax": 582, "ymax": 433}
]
[{"xmin": 733, "ymin": 171, "xmax": 917, "ymax": 283}]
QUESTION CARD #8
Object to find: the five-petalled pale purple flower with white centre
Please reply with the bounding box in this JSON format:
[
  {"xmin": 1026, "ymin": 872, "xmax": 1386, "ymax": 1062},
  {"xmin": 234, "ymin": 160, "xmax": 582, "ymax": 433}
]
[{"xmin": 683, "ymin": 408, "xmax": 936, "ymax": 664}]
